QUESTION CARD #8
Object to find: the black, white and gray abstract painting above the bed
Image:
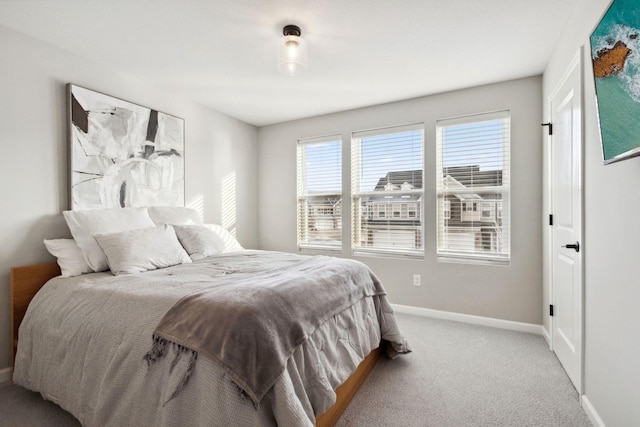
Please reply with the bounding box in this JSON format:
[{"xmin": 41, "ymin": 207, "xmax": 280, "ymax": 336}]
[{"xmin": 67, "ymin": 84, "xmax": 184, "ymax": 210}]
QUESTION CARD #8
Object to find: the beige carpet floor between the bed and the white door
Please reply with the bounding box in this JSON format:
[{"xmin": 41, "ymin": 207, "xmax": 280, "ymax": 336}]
[{"xmin": 338, "ymin": 314, "xmax": 591, "ymax": 427}]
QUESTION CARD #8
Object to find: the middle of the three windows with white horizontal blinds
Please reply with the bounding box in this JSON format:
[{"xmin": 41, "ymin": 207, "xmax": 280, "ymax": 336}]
[{"xmin": 351, "ymin": 123, "xmax": 424, "ymax": 255}]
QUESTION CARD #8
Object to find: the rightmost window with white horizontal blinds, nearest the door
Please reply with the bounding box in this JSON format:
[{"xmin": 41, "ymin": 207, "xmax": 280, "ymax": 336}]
[{"xmin": 436, "ymin": 111, "xmax": 511, "ymax": 262}]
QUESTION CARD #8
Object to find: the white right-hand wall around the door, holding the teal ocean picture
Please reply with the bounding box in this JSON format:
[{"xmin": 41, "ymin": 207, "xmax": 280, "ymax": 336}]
[{"xmin": 543, "ymin": 0, "xmax": 640, "ymax": 427}]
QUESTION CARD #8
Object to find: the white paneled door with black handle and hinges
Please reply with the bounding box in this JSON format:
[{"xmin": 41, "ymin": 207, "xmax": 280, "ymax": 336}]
[{"xmin": 549, "ymin": 50, "xmax": 584, "ymax": 394}]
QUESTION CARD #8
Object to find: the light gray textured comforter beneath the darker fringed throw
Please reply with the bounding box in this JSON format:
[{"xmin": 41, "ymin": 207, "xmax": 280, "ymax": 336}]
[{"xmin": 13, "ymin": 251, "xmax": 410, "ymax": 427}]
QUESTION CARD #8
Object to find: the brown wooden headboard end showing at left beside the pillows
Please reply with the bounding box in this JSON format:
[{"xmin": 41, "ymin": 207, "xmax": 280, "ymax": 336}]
[{"xmin": 9, "ymin": 263, "xmax": 60, "ymax": 363}]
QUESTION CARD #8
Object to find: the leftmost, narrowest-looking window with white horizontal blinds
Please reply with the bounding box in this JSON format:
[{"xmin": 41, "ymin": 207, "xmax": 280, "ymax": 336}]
[{"xmin": 297, "ymin": 135, "xmax": 342, "ymax": 249}]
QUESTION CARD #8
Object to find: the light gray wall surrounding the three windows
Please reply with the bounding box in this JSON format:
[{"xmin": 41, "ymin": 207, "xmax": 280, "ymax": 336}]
[{"xmin": 258, "ymin": 77, "xmax": 542, "ymax": 324}]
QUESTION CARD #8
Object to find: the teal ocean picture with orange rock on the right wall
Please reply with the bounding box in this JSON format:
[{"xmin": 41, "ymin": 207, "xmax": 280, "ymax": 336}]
[{"xmin": 590, "ymin": 0, "xmax": 640, "ymax": 164}]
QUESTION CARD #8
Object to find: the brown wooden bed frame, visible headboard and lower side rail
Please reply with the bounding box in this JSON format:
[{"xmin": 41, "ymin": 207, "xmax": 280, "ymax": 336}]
[{"xmin": 10, "ymin": 264, "xmax": 382, "ymax": 427}]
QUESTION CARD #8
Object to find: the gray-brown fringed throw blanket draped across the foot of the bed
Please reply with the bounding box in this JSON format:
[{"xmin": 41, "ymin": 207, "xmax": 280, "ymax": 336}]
[{"xmin": 145, "ymin": 252, "xmax": 410, "ymax": 406}]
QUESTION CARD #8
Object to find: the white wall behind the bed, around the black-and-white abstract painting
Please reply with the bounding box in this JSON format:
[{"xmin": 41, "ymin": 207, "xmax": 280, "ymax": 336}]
[{"xmin": 0, "ymin": 27, "xmax": 257, "ymax": 371}]
